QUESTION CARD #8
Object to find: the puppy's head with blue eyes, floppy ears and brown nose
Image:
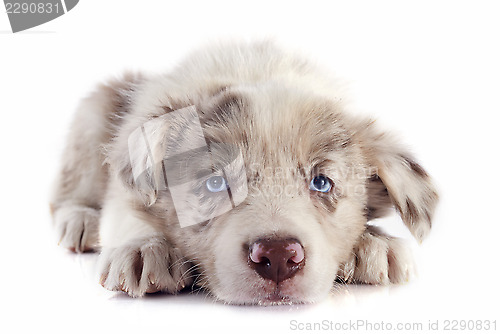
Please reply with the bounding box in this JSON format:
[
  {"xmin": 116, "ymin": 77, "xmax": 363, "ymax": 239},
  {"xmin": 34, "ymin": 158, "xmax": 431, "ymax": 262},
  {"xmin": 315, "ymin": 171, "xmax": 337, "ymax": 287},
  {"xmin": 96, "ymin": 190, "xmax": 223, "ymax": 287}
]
[{"xmin": 110, "ymin": 73, "xmax": 437, "ymax": 304}]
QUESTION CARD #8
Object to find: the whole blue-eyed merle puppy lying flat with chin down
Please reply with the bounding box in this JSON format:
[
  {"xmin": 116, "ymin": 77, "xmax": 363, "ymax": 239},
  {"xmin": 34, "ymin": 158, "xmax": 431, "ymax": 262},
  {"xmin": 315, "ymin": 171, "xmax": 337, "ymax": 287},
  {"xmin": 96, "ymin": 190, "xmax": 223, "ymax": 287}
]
[{"xmin": 51, "ymin": 42, "xmax": 438, "ymax": 304}]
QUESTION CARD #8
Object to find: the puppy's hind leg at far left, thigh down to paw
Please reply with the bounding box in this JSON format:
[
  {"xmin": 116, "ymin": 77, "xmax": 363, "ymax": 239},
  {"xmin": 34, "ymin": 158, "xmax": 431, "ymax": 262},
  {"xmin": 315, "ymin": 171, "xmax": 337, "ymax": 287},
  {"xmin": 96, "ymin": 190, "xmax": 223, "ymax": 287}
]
[{"xmin": 50, "ymin": 76, "xmax": 137, "ymax": 252}]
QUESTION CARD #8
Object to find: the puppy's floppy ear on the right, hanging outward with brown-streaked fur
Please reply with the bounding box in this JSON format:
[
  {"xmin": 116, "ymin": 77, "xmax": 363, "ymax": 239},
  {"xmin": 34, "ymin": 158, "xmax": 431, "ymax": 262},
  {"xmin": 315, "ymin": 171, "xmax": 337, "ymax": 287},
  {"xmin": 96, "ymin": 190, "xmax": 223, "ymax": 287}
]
[{"xmin": 355, "ymin": 118, "xmax": 438, "ymax": 241}]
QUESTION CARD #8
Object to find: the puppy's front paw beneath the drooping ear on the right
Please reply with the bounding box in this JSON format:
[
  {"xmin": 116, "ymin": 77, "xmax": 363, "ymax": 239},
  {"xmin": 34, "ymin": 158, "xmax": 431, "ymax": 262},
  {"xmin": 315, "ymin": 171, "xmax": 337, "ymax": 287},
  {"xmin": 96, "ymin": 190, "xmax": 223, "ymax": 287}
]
[{"xmin": 337, "ymin": 226, "xmax": 414, "ymax": 284}]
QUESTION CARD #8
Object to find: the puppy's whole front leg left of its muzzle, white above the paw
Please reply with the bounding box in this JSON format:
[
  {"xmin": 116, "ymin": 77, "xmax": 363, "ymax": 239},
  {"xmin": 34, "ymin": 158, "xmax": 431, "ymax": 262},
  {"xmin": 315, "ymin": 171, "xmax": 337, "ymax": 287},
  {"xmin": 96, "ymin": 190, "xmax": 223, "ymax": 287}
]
[{"xmin": 98, "ymin": 179, "xmax": 193, "ymax": 297}]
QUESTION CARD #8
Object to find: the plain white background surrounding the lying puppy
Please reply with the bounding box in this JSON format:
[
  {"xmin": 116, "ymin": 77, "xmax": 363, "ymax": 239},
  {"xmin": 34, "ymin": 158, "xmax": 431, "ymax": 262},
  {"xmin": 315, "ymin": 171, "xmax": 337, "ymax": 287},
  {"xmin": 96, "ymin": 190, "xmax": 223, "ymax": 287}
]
[{"xmin": 0, "ymin": 0, "xmax": 500, "ymax": 333}]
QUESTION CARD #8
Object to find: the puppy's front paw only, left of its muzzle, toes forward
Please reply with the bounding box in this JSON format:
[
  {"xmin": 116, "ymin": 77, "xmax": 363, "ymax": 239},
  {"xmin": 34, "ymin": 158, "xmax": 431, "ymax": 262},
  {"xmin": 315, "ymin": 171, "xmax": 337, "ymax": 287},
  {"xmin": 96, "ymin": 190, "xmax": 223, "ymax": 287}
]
[{"xmin": 99, "ymin": 237, "xmax": 193, "ymax": 297}]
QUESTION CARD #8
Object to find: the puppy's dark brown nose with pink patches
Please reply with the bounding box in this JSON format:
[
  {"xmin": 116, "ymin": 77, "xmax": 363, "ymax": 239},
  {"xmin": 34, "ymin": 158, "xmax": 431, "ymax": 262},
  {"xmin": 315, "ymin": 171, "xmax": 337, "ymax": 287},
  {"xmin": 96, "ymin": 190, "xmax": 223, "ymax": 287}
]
[{"xmin": 248, "ymin": 239, "xmax": 305, "ymax": 283}]
